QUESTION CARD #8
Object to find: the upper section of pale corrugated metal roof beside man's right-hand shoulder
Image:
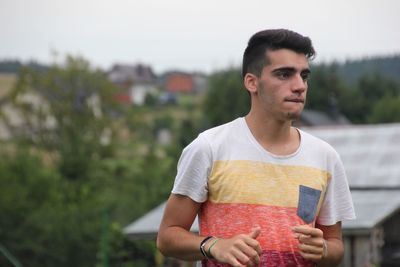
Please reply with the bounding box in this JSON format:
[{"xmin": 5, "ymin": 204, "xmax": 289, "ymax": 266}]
[{"xmin": 304, "ymin": 123, "xmax": 400, "ymax": 189}]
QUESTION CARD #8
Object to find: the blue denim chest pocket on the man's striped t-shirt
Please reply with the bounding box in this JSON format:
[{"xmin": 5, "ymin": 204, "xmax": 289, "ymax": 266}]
[{"xmin": 297, "ymin": 185, "xmax": 321, "ymax": 224}]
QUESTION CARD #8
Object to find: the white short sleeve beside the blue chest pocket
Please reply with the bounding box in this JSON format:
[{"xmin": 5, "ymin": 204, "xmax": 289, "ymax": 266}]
[{"xmin": 317, "ymin": 153, "xmax": 355, "ymax": 225}]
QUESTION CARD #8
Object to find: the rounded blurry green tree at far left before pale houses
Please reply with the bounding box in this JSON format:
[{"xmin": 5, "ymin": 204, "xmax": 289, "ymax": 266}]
[{"xmin": 10, "ymin": 56, "xmax": 116, "ymax": 180}]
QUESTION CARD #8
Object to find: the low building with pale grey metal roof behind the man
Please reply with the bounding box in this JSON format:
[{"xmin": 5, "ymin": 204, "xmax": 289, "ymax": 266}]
[{"xmin": 124, "ymin": 123, "xmax": 400, "ymax": 267}]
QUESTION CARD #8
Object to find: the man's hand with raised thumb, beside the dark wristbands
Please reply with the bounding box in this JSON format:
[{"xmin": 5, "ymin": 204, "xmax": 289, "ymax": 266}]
[{"xmin": 206, "ymin": 227, "xmax": 262, "ymax": 267}]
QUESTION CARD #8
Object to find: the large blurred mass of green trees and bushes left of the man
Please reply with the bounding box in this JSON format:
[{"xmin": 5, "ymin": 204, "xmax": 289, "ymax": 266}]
[{"xmin": 0, "ymin": 57, "xmax": 176, "ymax": 267}]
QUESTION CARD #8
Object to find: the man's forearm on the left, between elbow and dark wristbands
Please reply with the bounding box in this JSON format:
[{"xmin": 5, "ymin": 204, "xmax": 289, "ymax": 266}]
[{"xmin": 157, "ymin": 226, "xmax": 205, "ymax": 261}]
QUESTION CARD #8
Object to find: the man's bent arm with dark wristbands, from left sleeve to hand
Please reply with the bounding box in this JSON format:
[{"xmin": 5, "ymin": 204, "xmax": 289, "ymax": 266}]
[{"xmin": 157, "ymin": 194, "xmax": 262, "ymax": 266}]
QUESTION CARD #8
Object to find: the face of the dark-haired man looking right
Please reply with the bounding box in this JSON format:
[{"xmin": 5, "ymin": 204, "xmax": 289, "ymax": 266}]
[{"xmin": 257, "ymin": 49, "xmax": 310, "ymax": 120}]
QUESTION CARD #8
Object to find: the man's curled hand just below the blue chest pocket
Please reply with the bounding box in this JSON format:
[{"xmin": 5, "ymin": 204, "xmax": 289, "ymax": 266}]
[{"xmin": 293, "ymin": 225, "xmax": 327, "ymax": 263}]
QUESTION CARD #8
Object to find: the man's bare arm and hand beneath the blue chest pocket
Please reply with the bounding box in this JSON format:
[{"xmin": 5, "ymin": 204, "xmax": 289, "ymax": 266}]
[{"xmin": 294, "ymin": 222, "xmax": 344, "ymax": 266}]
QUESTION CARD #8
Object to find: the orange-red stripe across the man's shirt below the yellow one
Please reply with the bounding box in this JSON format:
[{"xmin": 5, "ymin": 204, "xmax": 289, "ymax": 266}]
[{"xmin": 200, "ymin": 201, "xmax": 310, "ymax": 253}]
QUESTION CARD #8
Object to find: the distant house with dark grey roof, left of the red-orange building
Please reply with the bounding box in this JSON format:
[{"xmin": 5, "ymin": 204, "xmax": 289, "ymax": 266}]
[{"xmin": 107, "ymin": 64, "xmax": 157, "ymax": 105}]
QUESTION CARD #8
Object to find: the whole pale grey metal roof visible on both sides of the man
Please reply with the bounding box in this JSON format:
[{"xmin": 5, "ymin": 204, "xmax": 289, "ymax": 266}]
[{"xmin": 124, "ymin": 123, "xmax": 400, "ymax": 238}]
